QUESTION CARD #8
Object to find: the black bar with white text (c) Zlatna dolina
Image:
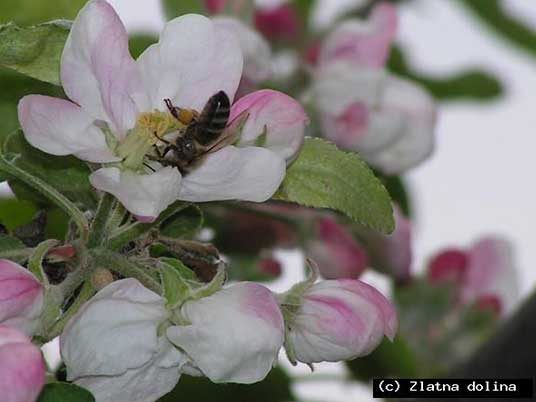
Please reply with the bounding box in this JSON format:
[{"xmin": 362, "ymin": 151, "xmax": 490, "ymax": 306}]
[{"xmin": 372, "ymin": 378, "xmax": 534, "ymax": 399}]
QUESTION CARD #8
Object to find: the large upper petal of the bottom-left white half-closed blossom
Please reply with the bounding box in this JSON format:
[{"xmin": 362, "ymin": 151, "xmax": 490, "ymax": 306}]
[{"xmin": 60, "ymin": 279, "xmax": 169, "ymax": 380}]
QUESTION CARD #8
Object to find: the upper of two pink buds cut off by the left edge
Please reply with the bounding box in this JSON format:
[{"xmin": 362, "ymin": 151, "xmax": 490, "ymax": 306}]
[{"xmin": 0, "ymin": 260, "xmax": 43, "ymax": 335}]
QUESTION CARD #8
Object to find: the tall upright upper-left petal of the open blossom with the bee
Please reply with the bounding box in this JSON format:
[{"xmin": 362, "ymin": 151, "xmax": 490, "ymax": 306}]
[{"xmin": 61, "ymin": 0, "xmax": 149, "ymax": 136}]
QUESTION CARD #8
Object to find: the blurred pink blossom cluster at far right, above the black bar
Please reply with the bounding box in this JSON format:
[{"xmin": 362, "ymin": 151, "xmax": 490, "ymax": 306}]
[{"xmin": 428, "ymin": 237, "xmax": 519, "ymax": 315}]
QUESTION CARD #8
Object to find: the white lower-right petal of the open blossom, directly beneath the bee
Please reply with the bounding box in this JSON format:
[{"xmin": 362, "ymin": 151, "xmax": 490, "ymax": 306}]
[{"xmin": 179, "ymin": 146, "xmax": 286, "ymax": 202}]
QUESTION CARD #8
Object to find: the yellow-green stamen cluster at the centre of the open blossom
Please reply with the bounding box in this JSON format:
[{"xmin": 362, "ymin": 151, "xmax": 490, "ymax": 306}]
[{"xmin": 116, "ymin": 110, "xmax": 185, "ymax": 170}]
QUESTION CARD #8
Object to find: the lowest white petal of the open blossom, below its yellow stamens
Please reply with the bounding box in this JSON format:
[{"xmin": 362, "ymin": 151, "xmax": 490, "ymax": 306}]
[{"xmin": 89, "ymin": 167, "xmax": 181, "ymax": 221}]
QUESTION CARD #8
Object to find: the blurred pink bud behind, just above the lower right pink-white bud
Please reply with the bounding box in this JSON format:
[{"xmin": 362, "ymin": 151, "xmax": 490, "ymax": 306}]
[{"xmin": 307, "ymin": 217, "xmax": 368, "ymax": 279}]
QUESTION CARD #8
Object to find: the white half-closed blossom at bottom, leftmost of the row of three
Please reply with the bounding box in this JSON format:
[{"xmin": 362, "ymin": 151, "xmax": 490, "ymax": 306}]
[{"xmin": 60, "ymin": 279, "xmax": 185, "ymax": 402}]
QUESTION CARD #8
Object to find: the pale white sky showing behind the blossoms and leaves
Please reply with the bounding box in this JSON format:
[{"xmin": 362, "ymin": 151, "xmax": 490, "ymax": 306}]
[{"xmin": 0, "ymin": 0, "xmax": 536, "ymax": 402}]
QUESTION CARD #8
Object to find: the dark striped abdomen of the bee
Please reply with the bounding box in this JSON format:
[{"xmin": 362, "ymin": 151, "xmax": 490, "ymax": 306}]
[{"xmin": 196, "ymin": 91, "xmax": 231, "ymax": 145}]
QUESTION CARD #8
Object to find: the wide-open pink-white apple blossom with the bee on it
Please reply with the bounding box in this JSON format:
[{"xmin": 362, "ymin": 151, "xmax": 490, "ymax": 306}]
[{"xmin": 19, "ymin": 0, "xmax": 307, "ymax": 221}]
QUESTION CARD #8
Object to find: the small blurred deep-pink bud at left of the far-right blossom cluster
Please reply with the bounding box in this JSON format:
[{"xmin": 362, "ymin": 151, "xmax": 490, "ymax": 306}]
[{"xmin": 428, "ymin": 249, "xmax": 467, "ymax": 284}]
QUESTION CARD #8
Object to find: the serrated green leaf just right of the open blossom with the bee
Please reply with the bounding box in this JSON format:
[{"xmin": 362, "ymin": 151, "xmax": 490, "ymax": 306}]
[{"xmin": 274, "ymin": 138, "xmax": 394, "ymax": 233}]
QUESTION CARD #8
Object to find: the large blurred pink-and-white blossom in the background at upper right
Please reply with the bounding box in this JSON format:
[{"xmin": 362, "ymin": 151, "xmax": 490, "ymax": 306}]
[{"xmin": 312, "ymin": 4, "xmax": 436, "ymax": 174}]
